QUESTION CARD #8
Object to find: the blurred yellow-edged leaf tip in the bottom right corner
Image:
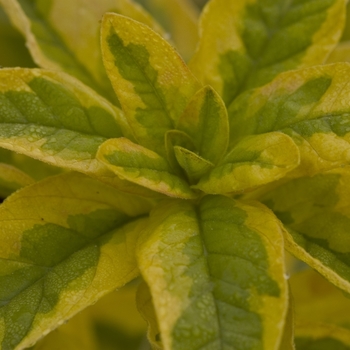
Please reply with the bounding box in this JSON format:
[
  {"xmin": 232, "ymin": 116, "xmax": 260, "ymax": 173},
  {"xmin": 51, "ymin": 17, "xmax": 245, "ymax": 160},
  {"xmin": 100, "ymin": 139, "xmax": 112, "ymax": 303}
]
[{"xmin": 295, "ymin": 323, "xmax": 350, "ymax": 350}]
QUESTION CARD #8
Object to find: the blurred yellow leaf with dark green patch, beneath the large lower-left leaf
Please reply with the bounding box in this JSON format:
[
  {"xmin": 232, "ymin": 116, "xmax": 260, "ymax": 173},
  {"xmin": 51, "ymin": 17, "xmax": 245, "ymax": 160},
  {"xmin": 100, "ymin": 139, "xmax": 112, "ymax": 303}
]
[{"xmin": 32, "ymin": 283, "xmax": 146, "ymax": 350}]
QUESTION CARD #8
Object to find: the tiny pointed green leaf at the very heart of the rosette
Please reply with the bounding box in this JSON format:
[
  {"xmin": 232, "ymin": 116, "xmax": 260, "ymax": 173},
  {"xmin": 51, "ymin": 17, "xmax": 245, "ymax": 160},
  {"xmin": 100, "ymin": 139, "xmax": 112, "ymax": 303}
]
[{"xmin": 174, "ymin": 146, "xmax": 214, "ymax": 182}]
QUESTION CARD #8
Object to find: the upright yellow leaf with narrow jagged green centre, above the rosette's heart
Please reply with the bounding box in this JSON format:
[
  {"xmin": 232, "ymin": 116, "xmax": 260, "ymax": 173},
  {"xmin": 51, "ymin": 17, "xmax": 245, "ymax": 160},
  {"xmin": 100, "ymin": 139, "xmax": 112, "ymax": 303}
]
[{"xmin": 102, "ymin": 14, "xmax": 199, "ymax": 156}]
